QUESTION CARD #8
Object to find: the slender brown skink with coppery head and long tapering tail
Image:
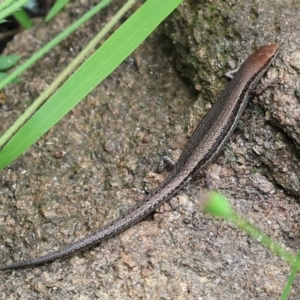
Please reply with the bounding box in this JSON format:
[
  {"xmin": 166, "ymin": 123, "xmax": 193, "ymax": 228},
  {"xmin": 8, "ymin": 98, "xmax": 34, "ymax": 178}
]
[{"xmin": 0, "ymin": 44, "xmax": 280, "ymax": 271}]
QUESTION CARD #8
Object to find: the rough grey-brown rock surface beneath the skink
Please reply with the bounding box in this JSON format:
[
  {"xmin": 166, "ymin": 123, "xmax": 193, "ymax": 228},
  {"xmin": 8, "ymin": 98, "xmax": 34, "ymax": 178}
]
[{"xmin": 0, "ymin": 0, "xmax": 300, "ymax": 300}]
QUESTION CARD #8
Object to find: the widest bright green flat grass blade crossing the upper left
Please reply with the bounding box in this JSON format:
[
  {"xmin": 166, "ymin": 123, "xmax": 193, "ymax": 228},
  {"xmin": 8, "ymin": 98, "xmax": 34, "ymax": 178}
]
[{"xmin": 0, "ymin": 0, "xmax": 182, "ymax": 169}]
